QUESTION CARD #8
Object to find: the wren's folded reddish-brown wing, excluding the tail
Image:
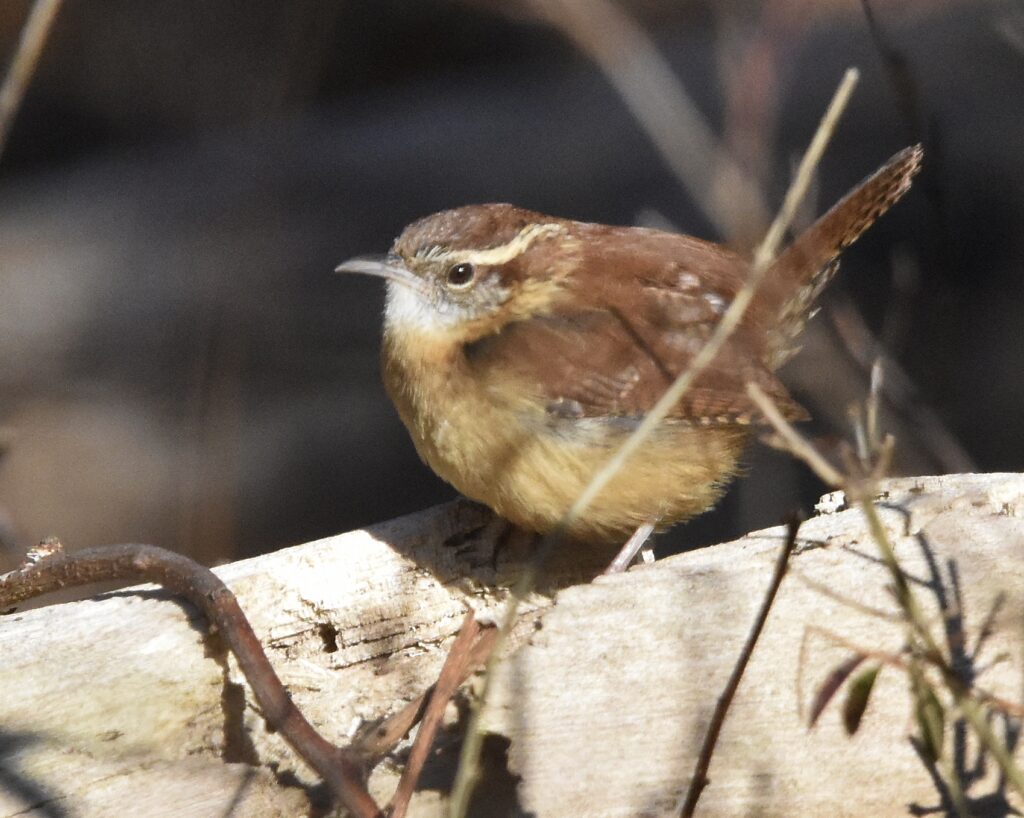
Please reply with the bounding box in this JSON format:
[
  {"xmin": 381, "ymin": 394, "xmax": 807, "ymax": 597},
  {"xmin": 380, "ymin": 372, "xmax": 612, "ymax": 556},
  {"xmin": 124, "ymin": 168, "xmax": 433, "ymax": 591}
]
[{"xmin": 466, "ymin": 235, "xmax": 807, "ymax": 424}]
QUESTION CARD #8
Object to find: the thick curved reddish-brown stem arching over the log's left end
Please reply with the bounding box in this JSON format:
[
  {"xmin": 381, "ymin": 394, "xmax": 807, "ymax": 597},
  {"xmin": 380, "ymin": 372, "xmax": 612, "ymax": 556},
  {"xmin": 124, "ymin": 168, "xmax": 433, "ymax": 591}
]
[{"xmin": 0, "ymin": 545, "xmax": 381, "ymax": 818}]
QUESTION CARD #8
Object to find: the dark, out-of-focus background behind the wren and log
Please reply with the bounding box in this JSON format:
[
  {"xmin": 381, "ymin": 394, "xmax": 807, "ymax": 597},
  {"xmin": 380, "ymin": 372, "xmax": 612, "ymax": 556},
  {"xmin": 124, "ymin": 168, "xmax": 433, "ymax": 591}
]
[{"xmin": 0, "ymin": 0, "xmax": 1024, "ymax": 564}]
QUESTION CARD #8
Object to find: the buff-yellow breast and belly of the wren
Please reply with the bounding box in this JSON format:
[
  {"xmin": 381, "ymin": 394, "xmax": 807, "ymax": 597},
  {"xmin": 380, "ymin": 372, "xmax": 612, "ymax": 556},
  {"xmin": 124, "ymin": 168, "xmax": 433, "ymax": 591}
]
[{"xmin": 384, "ymin": 325, "xmax": 746, "ymax": 542}]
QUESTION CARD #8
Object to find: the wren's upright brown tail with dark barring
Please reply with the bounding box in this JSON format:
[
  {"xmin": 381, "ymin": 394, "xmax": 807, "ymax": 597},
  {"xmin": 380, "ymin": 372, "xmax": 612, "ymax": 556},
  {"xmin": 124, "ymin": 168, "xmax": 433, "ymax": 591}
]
[{"xmin": 759, "ymin": 144, "xmax": 924, "ymax": 367}]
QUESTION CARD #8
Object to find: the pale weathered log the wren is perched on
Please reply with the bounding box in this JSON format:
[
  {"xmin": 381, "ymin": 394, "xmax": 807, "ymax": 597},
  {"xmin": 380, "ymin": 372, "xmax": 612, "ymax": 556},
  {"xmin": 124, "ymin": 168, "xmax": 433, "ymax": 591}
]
[{"xmin": 0, "ymin": 475, "xmax": 1024, "ymax": 818}]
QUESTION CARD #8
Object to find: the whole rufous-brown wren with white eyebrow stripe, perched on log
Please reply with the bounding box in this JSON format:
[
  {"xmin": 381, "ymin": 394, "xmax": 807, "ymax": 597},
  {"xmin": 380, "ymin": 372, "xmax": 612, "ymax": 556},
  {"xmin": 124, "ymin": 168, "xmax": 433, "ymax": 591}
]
[{"xmin": 338, "ymin": 145, "xmax": 922, "ymax": 543}]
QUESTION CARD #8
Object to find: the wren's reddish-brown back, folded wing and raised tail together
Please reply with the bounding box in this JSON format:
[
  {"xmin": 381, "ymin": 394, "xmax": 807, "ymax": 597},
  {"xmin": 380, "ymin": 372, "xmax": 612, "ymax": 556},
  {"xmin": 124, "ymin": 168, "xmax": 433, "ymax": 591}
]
[{"xmin": 466, "ymin": 146, "xmax": 921, "ymax": 424}]
